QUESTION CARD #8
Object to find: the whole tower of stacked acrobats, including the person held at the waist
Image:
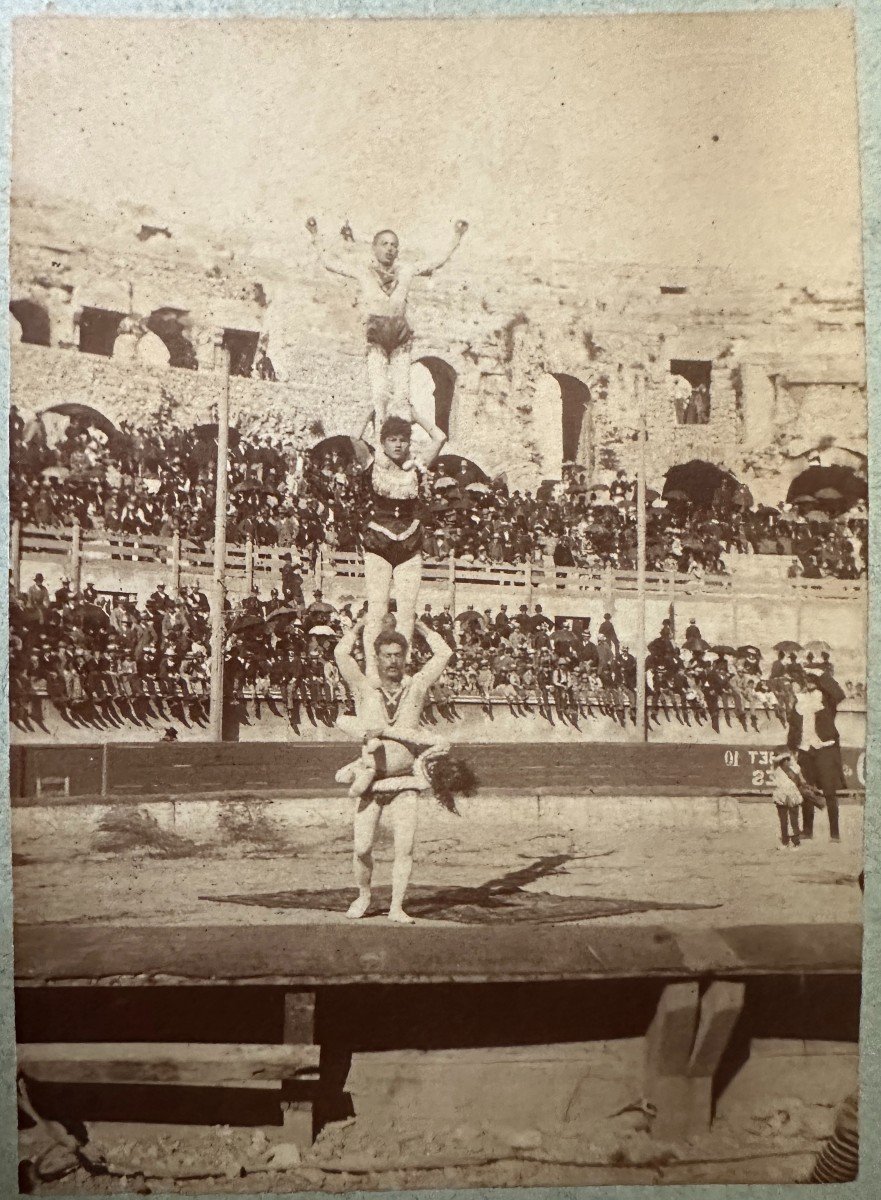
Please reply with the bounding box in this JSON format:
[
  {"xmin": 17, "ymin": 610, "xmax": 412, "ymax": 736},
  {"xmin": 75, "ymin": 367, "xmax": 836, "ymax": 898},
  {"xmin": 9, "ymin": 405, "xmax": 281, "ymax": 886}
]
[{"xmin": 306, "ymin": 217, "xmax": 475, "ymax": 925}]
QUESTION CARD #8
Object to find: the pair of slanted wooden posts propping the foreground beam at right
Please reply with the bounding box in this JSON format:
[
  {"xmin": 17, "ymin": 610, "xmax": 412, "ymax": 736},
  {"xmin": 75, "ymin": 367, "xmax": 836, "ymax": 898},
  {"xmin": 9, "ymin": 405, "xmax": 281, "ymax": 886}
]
[{"xmin": 645, "ymin": 980, "xmax": 745, "ymax": 1141}]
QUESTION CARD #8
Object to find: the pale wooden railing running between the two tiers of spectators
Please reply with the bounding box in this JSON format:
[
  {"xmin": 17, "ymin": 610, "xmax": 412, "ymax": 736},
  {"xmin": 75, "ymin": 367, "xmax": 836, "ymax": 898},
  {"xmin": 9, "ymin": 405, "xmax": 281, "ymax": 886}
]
[{"xmin": 10, "ymin": 522, "xmax": 865, "ymax": 604}]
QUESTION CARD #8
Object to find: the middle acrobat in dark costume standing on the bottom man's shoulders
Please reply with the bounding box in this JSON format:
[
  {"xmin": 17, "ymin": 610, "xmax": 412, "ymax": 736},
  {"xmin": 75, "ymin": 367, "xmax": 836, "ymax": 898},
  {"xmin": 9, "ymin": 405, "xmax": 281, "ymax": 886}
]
[{"xmin": 361, "ymin": 406, "xmax": 447, "ymax": 672}]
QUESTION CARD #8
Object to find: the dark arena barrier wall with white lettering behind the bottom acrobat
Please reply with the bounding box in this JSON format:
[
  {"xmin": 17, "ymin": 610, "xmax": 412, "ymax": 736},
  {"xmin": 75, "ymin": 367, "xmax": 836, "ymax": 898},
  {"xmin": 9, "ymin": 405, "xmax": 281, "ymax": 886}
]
[{"xmin": 10, "ymin": 737, "xmax": 865, "ymax": 804}]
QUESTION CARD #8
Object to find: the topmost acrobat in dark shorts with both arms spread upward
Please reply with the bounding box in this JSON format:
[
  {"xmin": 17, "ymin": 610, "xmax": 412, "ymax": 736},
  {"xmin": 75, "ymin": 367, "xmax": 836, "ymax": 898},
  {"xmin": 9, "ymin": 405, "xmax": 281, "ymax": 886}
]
[{"xmin": 306, "ymin": 217, "xmax": 468, "ymax": 438}]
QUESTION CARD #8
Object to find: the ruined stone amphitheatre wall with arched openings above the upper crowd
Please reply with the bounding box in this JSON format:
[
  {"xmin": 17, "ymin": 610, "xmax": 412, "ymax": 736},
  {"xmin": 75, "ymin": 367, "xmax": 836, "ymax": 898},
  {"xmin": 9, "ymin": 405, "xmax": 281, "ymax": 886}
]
[{"xmin": 11, "ymin": 202, "xmax": 868, "ymax": 503}]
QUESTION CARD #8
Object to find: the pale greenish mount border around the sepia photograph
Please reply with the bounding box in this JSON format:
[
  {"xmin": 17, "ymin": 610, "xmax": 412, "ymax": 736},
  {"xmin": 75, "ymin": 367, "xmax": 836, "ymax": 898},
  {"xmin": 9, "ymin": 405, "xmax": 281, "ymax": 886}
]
[{"xmin": 0, "ymin": 0, "xmax": 881, "ymax": 1200}]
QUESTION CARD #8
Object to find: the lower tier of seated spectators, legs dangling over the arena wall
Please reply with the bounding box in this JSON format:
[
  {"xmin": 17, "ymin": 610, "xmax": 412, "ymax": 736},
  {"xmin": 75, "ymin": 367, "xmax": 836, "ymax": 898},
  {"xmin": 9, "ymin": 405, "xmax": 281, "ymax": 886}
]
[{"xmin": 10, "ymin": 568, "xmax": 864, "ymax": 730}]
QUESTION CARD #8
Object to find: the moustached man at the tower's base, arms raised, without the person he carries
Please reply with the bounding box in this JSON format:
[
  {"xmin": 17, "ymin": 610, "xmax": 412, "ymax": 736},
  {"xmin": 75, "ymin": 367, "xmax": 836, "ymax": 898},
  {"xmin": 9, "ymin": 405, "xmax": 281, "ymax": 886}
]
[{"xmin": 334, "ymin": 620, "xmax": 453, "ymax": 925}]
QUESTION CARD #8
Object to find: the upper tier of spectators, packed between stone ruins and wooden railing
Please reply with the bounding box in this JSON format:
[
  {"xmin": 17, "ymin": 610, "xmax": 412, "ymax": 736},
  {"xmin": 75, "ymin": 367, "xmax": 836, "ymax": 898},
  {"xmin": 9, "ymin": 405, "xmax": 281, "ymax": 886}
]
[{"xmin": 10, "ymin": 408, "xmax": 867, "ymax": 578}]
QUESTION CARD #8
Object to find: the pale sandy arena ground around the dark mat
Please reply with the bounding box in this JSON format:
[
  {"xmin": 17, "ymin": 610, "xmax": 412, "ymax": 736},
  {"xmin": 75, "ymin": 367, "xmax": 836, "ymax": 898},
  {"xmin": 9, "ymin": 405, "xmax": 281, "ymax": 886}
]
[{"xmin": 13, "ymin": 797, "xmax": 863, "ymax": 929}]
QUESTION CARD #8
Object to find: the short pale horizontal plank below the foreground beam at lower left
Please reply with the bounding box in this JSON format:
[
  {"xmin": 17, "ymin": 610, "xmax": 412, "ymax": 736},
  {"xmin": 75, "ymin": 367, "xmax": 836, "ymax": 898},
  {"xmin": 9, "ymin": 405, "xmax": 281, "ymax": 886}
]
[{"xmin": 18, "ymin": 1042, "xmax": 319, "ymax": 1087}]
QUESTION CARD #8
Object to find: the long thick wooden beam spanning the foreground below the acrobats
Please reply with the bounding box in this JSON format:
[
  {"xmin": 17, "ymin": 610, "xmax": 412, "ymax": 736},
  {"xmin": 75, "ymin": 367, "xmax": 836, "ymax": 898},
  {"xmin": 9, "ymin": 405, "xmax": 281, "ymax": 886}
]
[{"xmin": 14, "ymin": 920, "xmax": 862, "ymax": 986}]
